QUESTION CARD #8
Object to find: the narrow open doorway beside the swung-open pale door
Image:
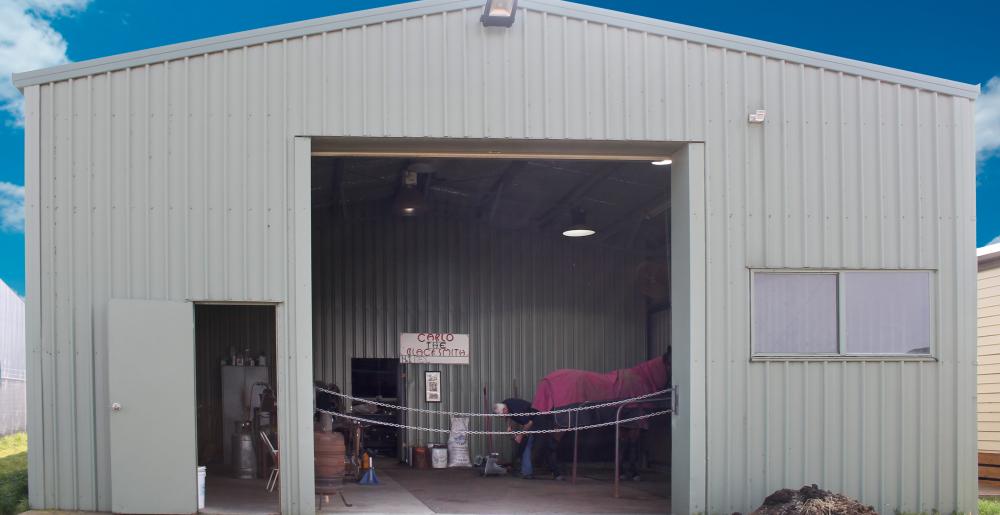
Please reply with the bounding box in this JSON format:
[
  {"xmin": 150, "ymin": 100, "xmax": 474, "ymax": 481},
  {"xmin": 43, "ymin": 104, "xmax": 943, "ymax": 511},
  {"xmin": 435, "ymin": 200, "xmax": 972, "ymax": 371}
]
[{"xmin": 195, "ymin": 304, "xmax": 280, "ymax": 514}]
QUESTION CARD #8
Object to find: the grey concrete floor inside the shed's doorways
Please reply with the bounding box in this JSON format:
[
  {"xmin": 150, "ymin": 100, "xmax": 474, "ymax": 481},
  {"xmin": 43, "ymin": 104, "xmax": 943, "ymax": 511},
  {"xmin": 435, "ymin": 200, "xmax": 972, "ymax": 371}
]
[{"xmin": 191, "ymin": 460, "xmax": 670, "ymax": 515}]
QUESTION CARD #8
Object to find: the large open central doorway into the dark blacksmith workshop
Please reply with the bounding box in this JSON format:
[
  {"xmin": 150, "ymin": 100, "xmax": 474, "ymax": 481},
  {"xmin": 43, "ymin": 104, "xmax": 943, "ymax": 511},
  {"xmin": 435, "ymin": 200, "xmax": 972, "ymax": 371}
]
[{"xmin": 312, "ymin": 148, "xmax": 671, "ymax": 513}]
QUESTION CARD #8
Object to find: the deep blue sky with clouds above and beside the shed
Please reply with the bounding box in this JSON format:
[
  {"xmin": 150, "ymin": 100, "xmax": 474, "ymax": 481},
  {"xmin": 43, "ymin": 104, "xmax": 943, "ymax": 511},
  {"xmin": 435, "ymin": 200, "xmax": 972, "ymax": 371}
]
[{"xmin": 0, "ymin": 0, "xmax": 1000, "ymax": 295}]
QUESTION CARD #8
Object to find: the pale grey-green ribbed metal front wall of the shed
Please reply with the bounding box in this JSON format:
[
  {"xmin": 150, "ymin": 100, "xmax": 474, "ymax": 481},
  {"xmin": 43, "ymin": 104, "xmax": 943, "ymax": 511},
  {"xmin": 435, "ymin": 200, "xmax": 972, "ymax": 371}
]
[{"xmin": 26, "ymin": 8, "xmax": 975, "ymax": 511}]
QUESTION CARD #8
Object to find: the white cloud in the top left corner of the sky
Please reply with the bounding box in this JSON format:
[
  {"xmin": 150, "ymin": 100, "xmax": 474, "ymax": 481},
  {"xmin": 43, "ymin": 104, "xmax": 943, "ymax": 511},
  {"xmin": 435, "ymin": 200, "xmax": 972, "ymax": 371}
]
[{"xmin": 0, "ymin": 0, "xmax": 90, "ymax": 125}]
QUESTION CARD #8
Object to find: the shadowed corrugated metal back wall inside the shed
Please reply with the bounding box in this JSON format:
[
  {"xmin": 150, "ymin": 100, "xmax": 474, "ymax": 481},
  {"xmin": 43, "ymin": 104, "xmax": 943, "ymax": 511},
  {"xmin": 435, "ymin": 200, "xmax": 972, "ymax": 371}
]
[{"xmin": 313, "ymin": 210, "xmax": 646, "ymax": 453}]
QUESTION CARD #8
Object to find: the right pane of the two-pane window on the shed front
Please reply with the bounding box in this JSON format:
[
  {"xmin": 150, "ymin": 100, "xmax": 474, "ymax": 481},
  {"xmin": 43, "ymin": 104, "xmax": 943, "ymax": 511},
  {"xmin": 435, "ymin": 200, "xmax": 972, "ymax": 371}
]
[{"xmin": 844, "ymin": 271, "xmax": 931, "ymax": 354}]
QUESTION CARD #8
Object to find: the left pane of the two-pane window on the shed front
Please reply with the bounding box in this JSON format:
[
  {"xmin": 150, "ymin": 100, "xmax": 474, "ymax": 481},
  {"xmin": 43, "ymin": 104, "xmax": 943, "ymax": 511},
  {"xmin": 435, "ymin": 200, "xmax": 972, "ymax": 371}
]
[{"xmin": 753, "ymin": 273, "xmax": 837, "ymax": 354}]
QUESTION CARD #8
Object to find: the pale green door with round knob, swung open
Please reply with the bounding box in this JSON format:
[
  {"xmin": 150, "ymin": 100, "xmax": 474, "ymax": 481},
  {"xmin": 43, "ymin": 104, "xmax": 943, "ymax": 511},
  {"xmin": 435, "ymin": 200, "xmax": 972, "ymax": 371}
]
[{"xmin": 108, "ymin": 299, "xmax": 198, "ymax": 513}]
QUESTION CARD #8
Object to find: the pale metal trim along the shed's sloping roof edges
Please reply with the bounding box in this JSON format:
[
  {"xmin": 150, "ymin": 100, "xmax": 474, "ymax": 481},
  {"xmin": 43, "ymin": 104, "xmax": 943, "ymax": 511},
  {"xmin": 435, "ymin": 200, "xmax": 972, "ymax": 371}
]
[{"xmin": 13, "ymin": 0, "xmax": 979, "ymax": 99}]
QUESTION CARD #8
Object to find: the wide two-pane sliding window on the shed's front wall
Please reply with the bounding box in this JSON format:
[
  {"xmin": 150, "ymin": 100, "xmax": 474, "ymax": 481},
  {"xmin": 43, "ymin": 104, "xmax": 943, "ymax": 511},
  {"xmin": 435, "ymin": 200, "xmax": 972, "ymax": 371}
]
[{"xmin": 751, "ymin": 270, "xmax": 932, "ymax": 357}]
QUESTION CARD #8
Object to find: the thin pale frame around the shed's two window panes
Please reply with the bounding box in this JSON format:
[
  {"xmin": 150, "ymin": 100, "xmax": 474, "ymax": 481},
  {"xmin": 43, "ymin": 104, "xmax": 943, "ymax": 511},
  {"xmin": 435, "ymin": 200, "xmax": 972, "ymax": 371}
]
[{"xmin": 747, "ymin": 268, "xmax": 939, "ymax": 361}]
